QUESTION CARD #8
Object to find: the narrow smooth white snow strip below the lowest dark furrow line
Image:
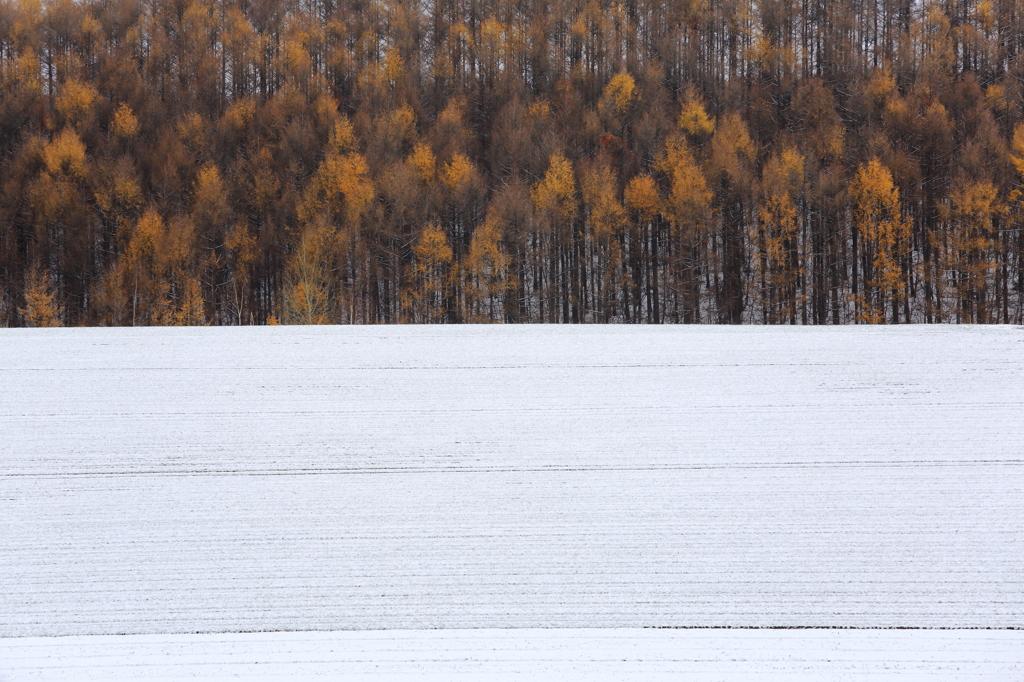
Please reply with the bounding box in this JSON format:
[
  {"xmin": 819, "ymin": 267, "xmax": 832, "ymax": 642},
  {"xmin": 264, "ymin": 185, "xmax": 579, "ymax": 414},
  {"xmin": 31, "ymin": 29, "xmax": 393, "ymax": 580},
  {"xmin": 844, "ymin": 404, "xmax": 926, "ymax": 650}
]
[{"xmin": 0, "ymin": 630, "xmax": 1024, "ymax": 682}]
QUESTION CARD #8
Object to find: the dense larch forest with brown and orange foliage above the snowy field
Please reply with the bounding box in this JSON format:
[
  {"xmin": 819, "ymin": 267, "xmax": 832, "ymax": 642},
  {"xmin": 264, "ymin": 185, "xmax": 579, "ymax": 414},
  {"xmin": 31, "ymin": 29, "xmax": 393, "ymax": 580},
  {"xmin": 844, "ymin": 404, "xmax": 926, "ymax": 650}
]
[{"xmin": 0, "ymin": 0, "xmax": 1024, "ymax": 326}]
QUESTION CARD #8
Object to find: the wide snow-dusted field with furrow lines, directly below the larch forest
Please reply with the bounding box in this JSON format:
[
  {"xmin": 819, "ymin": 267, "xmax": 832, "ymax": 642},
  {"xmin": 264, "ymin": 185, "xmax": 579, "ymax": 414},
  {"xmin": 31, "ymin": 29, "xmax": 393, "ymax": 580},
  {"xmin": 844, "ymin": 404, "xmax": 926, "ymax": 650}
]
[{"xmin": 0, "ymin": 327, "xmax": 1024, "ymax": 679}]
